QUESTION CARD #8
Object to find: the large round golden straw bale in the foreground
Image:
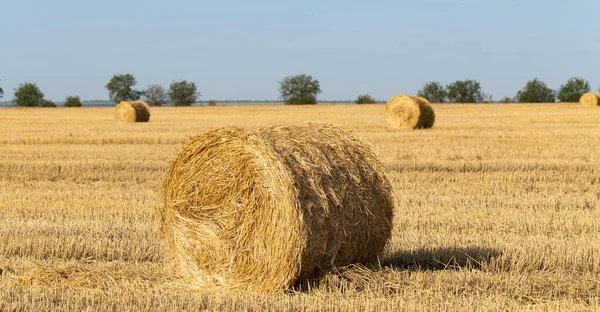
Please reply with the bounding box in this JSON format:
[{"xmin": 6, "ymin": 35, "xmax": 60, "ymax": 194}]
[{"xmin": 159, "ymin": 123, "xmax": 393, "ymax": 293}]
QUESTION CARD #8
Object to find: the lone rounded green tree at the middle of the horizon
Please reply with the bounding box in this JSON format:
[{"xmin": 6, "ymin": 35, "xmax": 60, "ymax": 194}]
[{"xmin": 279, "ymin": 74, "xmax": 321, "ymax": 104}]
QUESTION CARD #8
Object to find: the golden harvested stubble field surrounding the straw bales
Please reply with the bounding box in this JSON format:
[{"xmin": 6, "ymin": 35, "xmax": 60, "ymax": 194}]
[{"xmin": 0, "ymin": 104, "xmax": 600, "ymax": 311}]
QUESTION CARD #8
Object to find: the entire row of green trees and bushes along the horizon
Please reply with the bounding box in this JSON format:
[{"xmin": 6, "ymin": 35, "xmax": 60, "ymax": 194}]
[{"xmin": 0, "ymin": 74, "xmax": 591, "ymax": 107}]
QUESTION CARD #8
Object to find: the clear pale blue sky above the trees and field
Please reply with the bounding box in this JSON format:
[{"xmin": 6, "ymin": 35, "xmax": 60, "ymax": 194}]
[{"xmin": 0, "ymin": 0, "xmax": 600, "ymax": 101}]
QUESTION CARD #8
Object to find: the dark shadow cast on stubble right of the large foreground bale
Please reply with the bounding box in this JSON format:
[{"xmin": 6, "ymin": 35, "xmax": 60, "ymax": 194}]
[{"xmin": 381, "ymin": 247, "xmax": 502, "ymax": 271}]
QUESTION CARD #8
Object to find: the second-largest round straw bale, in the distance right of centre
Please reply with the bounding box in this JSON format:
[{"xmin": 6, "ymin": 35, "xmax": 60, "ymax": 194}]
[{"xmin": 384, "ymin": 94, "xmax": 435, "ymax": 129}]
